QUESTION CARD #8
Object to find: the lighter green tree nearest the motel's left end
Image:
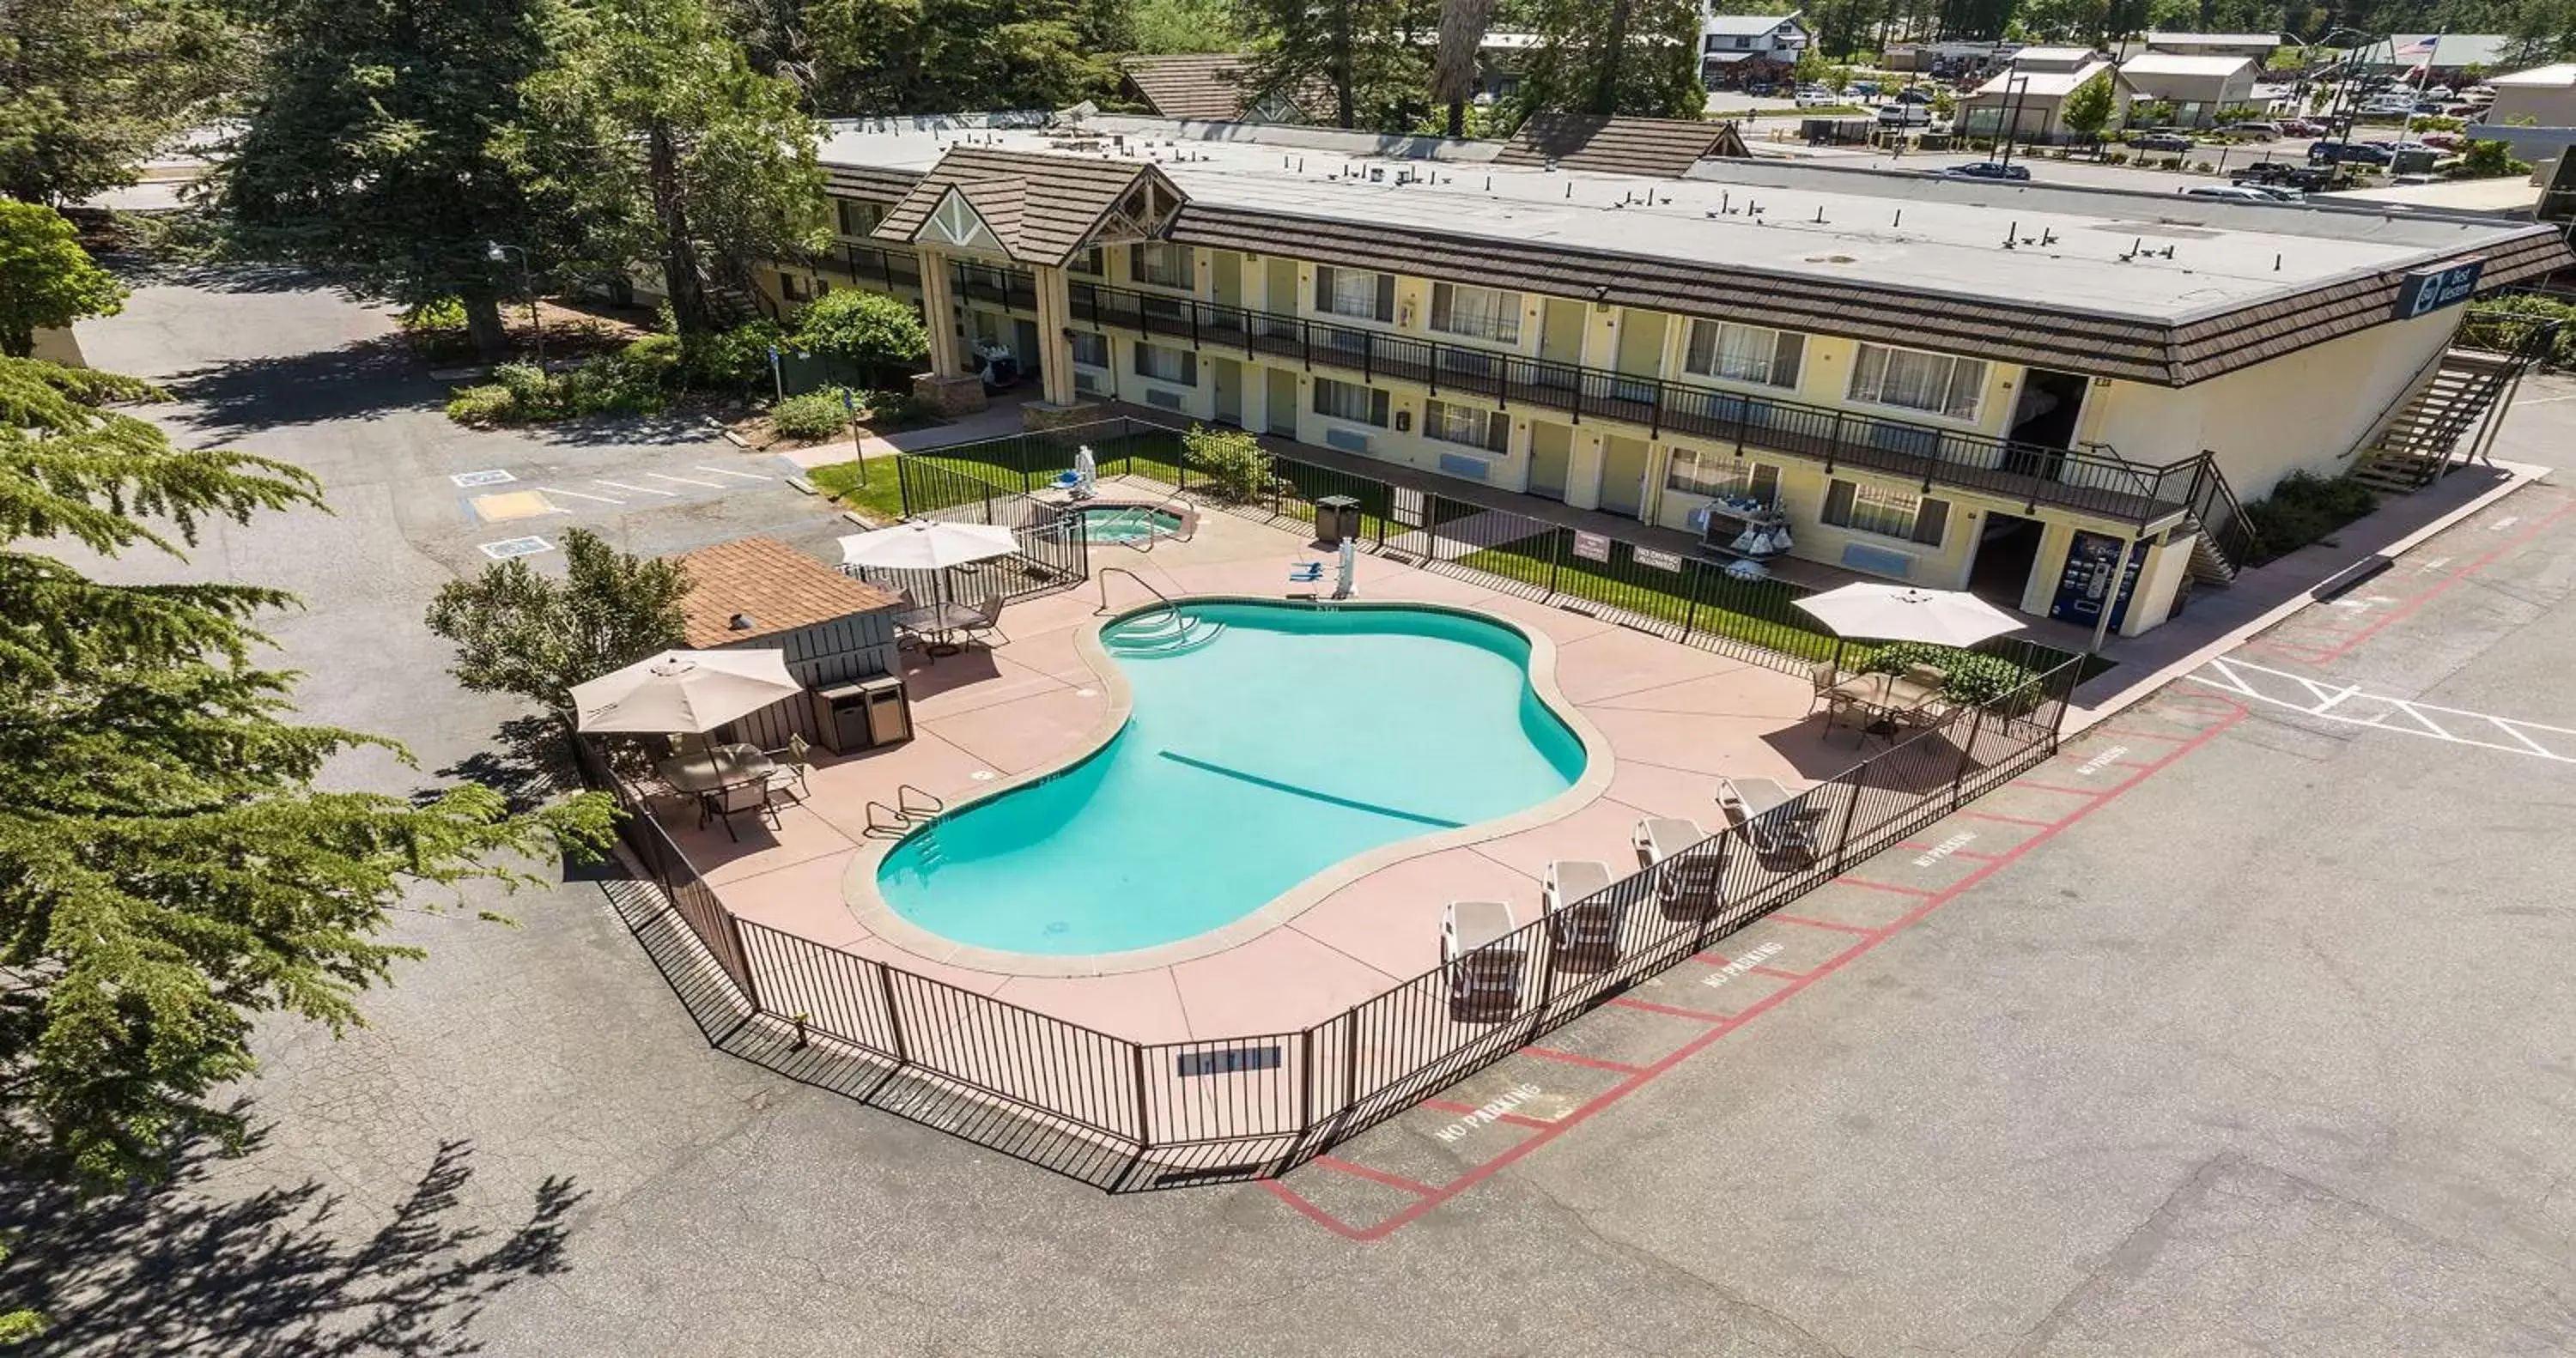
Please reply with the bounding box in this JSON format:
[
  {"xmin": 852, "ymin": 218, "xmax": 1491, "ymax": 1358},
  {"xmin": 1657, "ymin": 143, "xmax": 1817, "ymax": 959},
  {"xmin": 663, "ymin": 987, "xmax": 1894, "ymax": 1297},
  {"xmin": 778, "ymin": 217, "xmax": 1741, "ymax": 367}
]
[{"xmin": 507, "ymin": 0, "xmax": 827, "ymax": 337}]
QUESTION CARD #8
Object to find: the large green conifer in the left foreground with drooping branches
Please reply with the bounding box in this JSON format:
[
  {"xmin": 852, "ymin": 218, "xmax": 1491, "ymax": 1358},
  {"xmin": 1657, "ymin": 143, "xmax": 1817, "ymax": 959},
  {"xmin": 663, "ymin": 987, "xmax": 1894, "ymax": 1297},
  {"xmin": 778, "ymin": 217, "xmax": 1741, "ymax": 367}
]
[{"xmin": 0, "ymin": 358, "xmax": 613, "ymax": 1188}]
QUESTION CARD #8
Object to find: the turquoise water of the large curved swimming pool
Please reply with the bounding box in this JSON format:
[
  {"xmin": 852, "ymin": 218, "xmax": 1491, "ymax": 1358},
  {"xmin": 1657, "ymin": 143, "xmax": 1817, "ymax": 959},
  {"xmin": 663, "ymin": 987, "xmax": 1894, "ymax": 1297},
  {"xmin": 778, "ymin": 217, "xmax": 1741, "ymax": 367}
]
[{"xmin": 876, "ymin": 603, "xmax": 1584, "ymax": 954}]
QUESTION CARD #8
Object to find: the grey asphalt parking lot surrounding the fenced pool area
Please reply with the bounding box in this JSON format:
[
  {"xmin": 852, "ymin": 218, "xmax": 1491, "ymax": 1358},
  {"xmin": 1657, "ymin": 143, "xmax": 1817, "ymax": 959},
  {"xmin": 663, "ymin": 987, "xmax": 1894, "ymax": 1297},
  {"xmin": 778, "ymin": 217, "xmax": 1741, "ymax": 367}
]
[{"xmin": 0, "ymin": 278, "xmax": 2576, "ymax": 1358}]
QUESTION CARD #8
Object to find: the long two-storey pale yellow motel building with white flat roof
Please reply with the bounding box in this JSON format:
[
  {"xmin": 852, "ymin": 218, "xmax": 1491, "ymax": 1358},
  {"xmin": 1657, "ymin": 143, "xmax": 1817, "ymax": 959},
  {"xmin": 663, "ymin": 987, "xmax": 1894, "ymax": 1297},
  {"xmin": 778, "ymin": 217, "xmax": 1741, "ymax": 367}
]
[{"xmin": 765, "ymin": 113, "xmax": 2571, "ymax": 634}]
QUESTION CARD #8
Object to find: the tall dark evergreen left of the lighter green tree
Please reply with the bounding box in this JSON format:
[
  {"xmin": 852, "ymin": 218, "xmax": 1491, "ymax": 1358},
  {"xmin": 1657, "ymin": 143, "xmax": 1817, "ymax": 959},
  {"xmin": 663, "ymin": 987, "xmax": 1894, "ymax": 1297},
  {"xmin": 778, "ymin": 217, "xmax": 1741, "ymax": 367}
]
[{"xmin": 216, "ymin": 0, "xmax": 546, "ymax": 355}]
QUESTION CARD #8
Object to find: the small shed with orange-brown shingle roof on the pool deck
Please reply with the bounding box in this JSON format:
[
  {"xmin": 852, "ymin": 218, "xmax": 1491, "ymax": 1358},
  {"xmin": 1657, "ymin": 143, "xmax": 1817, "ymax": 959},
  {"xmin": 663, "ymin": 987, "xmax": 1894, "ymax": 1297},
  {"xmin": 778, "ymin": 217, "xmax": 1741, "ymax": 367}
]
[{"xmin": 677, "ymin": 538, "xmax": 896, "ymax": 750}]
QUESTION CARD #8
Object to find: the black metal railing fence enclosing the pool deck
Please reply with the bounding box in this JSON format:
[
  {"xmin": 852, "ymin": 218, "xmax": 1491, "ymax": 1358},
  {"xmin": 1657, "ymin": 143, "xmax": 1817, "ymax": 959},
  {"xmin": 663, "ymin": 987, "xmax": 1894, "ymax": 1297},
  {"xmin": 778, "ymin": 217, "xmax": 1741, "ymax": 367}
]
[{"xmin": 577, "ymin": 417, "xmax": 2081, "ymax": 1191}]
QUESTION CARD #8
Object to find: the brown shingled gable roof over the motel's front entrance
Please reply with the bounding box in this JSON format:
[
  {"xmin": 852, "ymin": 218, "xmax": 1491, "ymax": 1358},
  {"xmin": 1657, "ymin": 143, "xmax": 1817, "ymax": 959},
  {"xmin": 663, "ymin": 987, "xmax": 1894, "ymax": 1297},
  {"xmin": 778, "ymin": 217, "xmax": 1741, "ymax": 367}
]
[{"xmin": 871, "ymin": 147, "xmax": 1182, "ymax": 265}]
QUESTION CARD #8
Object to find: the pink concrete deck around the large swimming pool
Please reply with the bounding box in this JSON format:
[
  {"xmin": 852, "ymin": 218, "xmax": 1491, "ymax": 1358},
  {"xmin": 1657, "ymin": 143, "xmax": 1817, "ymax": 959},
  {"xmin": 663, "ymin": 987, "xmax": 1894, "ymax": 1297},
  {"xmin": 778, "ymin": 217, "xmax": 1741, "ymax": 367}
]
[{"xmin": 641, "ymin": 497, "xmax": 1860, "ymax": 1044}]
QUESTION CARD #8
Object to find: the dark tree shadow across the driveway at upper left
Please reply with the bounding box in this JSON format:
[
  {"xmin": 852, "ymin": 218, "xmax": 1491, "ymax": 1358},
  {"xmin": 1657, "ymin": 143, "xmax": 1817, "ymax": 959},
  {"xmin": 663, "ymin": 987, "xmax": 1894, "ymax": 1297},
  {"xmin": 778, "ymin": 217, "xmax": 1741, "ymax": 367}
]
[{"xmin": 162, "ymin": 335, "xmax": 446, "ymax": 438}]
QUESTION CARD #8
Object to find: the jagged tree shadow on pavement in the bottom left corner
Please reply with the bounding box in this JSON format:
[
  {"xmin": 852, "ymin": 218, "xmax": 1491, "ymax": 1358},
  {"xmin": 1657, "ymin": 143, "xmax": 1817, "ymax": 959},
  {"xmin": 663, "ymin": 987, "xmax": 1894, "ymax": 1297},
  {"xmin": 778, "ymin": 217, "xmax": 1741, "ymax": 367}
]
[{"xmin": 0, "ymin": 1142, "xmax": 582, "ymax": 1358}]
